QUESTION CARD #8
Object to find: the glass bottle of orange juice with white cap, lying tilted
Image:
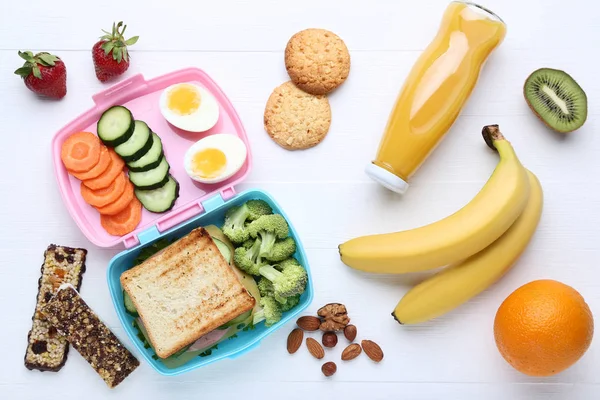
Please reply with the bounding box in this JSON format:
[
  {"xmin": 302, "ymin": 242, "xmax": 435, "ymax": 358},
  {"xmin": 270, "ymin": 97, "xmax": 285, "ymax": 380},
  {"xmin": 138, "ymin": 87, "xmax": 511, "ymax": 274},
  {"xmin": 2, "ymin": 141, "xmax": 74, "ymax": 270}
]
[{"xmin": 366, "ymin": 1, "xmax": 506, "ymax": 193}]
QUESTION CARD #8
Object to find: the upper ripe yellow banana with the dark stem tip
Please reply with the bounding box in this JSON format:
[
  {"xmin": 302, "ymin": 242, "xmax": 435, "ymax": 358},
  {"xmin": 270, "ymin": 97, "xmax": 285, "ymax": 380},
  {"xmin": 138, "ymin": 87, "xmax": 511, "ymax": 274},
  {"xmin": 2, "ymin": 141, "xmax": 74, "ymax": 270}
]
[{"xmin": 339, "ymin": 125, "xmax": 529, "ymax": 273}]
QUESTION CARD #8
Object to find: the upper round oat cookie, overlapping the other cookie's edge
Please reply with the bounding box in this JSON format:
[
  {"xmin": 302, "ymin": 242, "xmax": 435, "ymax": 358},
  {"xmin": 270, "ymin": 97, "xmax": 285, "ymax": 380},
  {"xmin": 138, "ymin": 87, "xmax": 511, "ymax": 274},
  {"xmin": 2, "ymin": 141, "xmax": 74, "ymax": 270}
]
[{"xmin": 285, "ymin": 28, "xmax": 350, "ymax": 94}]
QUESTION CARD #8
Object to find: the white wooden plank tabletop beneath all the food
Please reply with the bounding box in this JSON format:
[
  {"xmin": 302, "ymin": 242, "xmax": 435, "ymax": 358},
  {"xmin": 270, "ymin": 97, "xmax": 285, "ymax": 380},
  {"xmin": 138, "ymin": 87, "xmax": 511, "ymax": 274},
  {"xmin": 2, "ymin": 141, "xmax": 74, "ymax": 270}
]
[{"xmin": 0, "ymin": 0, "xmax": 600, "ymax": 400}]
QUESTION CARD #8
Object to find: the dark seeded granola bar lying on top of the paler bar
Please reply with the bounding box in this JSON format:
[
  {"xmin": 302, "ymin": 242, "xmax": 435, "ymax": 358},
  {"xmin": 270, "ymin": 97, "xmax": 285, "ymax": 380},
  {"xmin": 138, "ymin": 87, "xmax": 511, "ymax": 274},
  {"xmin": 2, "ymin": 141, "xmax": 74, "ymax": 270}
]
[{"xmin": 42, "ymin": 285, "xmax": 140, "ymax": 388}]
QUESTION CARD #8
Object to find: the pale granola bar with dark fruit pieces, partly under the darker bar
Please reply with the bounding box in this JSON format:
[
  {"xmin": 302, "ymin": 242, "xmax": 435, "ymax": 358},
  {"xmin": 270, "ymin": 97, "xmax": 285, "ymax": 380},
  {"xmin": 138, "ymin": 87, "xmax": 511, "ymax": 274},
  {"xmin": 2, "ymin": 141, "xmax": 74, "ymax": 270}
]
[{"xmin": 25, "ymin": 244, "xmax": 87, "ymax": 372}]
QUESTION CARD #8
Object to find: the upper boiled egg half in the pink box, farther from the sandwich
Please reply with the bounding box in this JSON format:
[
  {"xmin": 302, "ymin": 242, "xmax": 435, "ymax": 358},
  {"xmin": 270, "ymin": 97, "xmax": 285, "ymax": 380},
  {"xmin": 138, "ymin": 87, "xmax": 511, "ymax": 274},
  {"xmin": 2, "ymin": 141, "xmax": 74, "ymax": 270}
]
[{"xmin": 159, "ymin": 83, "xmax": 219, "ymax": 132}]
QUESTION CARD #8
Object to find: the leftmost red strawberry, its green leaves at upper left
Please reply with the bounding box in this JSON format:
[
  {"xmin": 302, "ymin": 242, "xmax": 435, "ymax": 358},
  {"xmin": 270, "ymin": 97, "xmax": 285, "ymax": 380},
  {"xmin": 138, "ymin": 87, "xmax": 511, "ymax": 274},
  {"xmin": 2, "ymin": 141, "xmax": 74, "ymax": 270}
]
[{"xmin": 15, "ymin": 51, "xmax": 67, "ymax": 99}]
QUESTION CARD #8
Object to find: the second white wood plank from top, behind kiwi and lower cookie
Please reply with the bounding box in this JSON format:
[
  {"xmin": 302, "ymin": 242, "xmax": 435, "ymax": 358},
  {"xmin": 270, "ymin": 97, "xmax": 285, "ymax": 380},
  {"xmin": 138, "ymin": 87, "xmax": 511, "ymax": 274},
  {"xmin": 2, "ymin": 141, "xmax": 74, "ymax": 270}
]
[{"xmin": 0, "ymin": 51, "xmax": 600, "ymax": 191}]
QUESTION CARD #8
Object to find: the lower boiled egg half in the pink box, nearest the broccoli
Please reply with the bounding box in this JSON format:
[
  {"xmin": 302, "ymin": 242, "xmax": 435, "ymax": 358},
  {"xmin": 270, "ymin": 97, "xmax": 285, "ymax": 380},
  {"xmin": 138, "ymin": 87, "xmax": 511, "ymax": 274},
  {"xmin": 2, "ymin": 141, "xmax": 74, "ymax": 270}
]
[{"xmin": 184, "ymin": 133, "xmax": 247, "ymax": 183}]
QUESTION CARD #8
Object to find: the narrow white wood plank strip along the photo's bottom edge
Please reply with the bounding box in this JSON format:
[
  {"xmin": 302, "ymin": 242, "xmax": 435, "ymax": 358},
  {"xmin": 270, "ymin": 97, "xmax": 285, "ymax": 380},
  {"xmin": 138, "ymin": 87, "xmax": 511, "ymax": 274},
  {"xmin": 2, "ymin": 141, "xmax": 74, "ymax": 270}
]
[{"xmin": 7, "ymin": 379, "xmax": 599, "ymax": 400}]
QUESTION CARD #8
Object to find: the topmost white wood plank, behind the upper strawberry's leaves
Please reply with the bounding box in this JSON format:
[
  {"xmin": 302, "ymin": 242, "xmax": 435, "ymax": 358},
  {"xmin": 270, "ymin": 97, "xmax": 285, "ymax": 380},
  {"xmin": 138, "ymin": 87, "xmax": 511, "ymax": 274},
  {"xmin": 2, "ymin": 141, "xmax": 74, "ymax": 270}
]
[{"xmin": 0, "ymin": 0, "xmax": 600, "ymax": 52}]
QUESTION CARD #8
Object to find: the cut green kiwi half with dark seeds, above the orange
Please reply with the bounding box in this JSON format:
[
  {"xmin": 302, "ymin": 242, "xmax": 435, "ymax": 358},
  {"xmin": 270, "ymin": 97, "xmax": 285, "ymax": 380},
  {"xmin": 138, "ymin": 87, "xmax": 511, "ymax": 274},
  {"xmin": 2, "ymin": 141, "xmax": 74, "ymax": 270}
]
[{"xmin": 523, "ymin": 68, "xmax": 587, "ymax": 133}]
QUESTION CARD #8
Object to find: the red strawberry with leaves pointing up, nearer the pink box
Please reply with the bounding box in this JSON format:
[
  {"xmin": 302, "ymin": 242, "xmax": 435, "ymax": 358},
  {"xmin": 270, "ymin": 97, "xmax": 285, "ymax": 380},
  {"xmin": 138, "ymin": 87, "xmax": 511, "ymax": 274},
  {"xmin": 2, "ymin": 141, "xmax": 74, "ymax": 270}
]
[{"xmin": 92, "ymin": 21, "xmax": 139, "ymax": 82}]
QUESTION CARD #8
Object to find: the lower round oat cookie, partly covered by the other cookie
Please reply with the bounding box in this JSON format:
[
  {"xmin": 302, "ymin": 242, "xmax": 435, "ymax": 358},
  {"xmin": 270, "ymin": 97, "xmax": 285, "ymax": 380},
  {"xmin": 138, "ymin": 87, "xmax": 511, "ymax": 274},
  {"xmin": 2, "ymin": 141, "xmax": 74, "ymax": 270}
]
[{"xmin": 264, "ymin": 81, "xmax": 331, "ymax": 150}]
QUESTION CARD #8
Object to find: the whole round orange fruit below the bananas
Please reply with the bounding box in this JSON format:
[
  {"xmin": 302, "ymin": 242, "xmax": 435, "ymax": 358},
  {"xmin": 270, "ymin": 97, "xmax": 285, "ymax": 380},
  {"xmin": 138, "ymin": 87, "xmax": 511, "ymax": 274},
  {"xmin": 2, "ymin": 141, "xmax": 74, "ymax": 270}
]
[{"xmin": 494, "ymin": 280, "xmax": 594, "ymax": 376}]
